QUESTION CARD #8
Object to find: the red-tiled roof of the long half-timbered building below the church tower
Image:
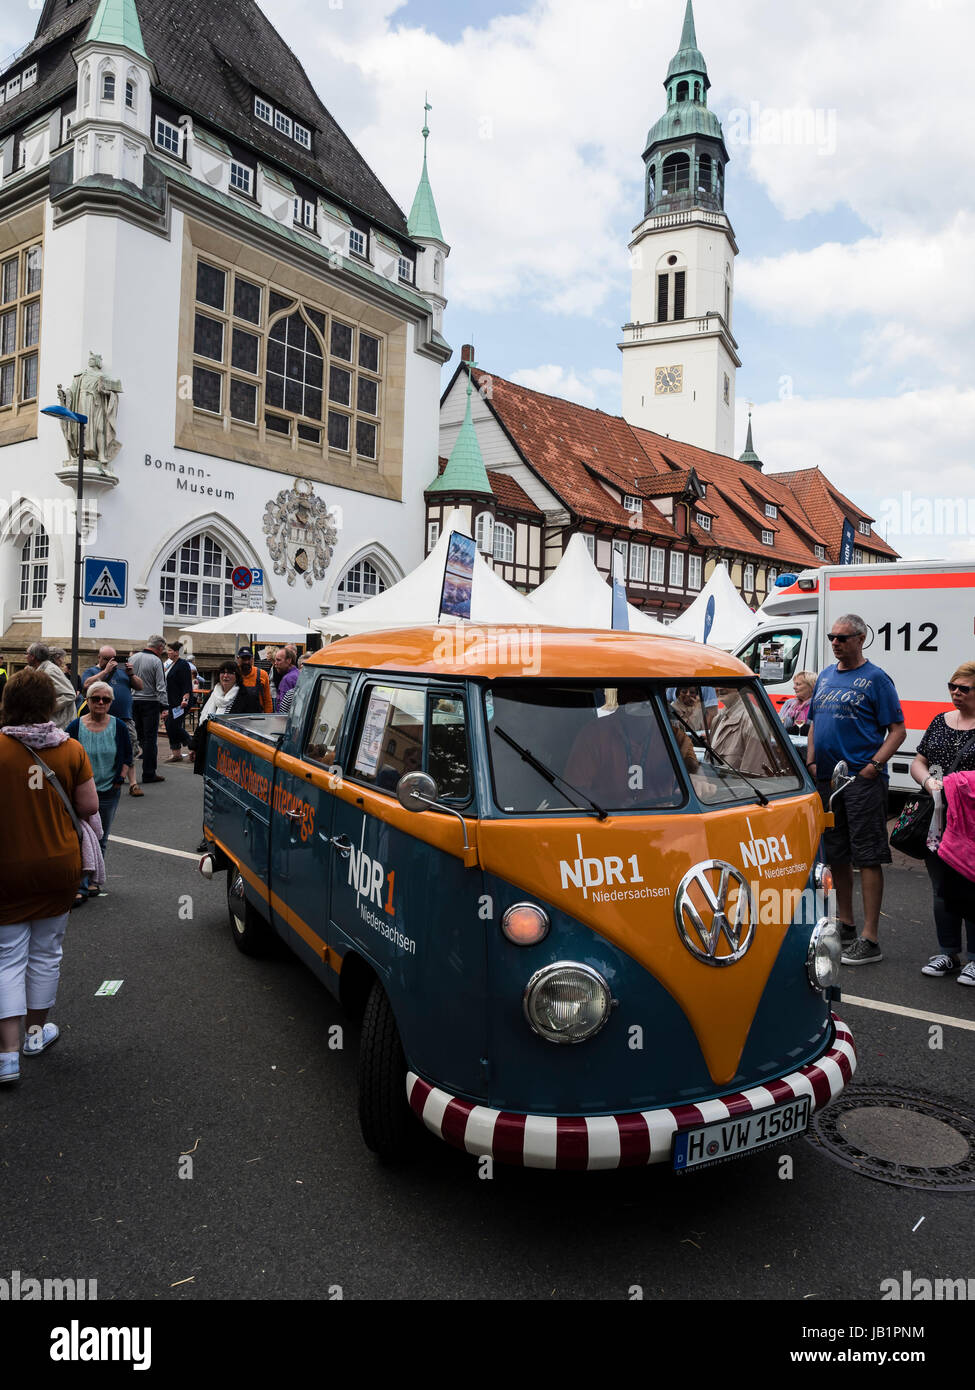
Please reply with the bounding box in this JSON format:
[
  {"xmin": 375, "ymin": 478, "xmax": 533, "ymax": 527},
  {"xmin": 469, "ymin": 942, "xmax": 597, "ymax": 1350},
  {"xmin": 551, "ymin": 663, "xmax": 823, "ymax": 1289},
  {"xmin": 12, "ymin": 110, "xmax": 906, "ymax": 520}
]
[{"xmin": 448, "ymin": 368, "xmax": 896, "ymax": 570}]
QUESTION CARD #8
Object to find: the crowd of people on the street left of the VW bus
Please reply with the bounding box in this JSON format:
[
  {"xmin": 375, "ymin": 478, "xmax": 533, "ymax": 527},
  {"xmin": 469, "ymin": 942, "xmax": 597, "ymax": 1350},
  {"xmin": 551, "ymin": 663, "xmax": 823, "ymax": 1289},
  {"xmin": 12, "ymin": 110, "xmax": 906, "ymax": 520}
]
[{"xmin": 0, "ymin": 635, "xmax": 307, "ymax": 1083}]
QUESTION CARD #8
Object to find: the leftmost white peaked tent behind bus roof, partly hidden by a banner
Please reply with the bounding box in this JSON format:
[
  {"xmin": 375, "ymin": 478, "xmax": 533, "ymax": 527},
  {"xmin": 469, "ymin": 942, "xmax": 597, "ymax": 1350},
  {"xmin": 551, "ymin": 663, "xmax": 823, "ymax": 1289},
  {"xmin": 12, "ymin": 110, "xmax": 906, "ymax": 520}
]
[{"xmin": 313, "ymin": 512, "xmax": 540, "ymax": 637}]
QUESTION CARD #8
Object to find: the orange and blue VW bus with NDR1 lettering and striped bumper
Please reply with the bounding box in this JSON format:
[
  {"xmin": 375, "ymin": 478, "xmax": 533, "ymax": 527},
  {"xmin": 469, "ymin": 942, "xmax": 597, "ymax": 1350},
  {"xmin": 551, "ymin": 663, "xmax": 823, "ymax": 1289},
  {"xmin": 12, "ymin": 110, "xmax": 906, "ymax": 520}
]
[{"xmin": 203, "ymin": 624, "xmax": 855, "ymax": 1172}]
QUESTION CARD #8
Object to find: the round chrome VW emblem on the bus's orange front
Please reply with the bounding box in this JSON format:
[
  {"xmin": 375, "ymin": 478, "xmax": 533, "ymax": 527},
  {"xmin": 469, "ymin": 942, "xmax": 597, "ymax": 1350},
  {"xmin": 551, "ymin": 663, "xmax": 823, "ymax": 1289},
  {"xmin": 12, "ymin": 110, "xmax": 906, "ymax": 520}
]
[{"xmin": 673, "ymin": 859, "xmax": 758, "ymax": 966}]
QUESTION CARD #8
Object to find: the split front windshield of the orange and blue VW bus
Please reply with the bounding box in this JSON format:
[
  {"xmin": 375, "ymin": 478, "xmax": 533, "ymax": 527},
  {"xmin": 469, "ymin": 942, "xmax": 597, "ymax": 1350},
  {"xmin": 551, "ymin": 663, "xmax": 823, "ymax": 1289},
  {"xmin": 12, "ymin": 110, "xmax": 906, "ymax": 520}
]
[{"xmin": 484, "ymin": 681, "xmax": 803, "ymax": 815}]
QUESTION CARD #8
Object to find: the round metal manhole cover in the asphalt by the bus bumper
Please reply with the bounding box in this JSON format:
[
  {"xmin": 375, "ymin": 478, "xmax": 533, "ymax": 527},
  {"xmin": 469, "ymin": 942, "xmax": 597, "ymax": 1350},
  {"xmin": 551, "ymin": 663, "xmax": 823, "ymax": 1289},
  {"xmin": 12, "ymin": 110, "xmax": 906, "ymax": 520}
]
[{"xmin": 807, "ymin": 1086, "xmax": 975, "ymax": 1193}]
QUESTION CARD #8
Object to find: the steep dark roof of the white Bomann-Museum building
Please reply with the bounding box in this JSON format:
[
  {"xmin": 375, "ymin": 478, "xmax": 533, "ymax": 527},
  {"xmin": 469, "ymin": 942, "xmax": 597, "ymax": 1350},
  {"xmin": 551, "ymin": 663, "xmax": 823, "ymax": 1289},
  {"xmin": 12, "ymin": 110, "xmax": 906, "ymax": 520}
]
[{"xmin": 0, "ymin": 0, "xmax": 408, "ymax": 238}]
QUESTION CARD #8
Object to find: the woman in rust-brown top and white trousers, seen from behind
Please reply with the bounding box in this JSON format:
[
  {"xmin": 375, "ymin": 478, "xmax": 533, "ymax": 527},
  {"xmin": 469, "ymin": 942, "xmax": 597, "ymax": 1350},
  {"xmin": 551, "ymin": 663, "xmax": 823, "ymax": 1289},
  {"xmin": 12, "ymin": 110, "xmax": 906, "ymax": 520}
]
[{"xmin": 0, "ymin": 669, "xmax": 99, "ymax": 1081}]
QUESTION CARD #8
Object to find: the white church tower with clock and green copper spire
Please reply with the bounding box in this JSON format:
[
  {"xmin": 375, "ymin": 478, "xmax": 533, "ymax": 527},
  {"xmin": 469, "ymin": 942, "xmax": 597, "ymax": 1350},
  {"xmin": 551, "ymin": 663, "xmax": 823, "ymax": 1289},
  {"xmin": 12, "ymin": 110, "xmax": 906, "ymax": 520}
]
[{"xmin": 619, "ymin": 0, "xmax": 741, "ymax": 456}]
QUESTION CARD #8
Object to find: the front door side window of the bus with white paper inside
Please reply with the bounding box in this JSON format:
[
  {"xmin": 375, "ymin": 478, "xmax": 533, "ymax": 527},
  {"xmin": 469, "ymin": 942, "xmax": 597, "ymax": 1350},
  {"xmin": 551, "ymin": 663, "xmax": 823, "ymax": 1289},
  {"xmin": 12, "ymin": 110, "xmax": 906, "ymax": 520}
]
[{"xmin": 350, "ymin": 685, "xmax": 470, "ymax": 801}]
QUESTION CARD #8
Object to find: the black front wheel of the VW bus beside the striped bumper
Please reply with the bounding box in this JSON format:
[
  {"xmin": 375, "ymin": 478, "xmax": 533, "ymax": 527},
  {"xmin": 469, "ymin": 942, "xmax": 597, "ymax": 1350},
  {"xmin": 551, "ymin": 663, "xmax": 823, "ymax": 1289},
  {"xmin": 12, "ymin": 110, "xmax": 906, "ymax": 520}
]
[{"xmin": 359, "ymin": 980, "xmax": 417, "ymax": 1163}]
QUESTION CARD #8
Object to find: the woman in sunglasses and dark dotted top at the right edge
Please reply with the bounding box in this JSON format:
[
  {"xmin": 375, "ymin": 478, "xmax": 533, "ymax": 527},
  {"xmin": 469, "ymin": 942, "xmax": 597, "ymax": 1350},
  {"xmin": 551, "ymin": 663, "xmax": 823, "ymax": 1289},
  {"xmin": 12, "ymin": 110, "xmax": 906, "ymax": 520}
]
[{"xmin": 911, "ymin": 662, "xmax": 975, "ymax": 986}]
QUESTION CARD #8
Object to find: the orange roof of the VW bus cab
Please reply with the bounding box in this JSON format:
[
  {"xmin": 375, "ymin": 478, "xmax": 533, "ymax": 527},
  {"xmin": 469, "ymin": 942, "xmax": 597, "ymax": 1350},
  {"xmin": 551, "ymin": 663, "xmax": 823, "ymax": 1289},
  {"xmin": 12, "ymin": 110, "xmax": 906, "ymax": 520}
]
[{"xmin": 306, "ymin": 623, "xmax": 754, "ymax": 685}]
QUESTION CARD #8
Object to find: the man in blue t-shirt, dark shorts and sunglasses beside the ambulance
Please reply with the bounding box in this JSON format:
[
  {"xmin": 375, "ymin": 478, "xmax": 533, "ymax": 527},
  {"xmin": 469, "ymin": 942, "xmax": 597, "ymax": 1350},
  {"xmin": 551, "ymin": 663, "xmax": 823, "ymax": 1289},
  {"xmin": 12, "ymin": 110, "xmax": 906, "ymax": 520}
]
[{"xmin": 805, "ymin": 613, "xmax": 907, "ymax": 965}]
